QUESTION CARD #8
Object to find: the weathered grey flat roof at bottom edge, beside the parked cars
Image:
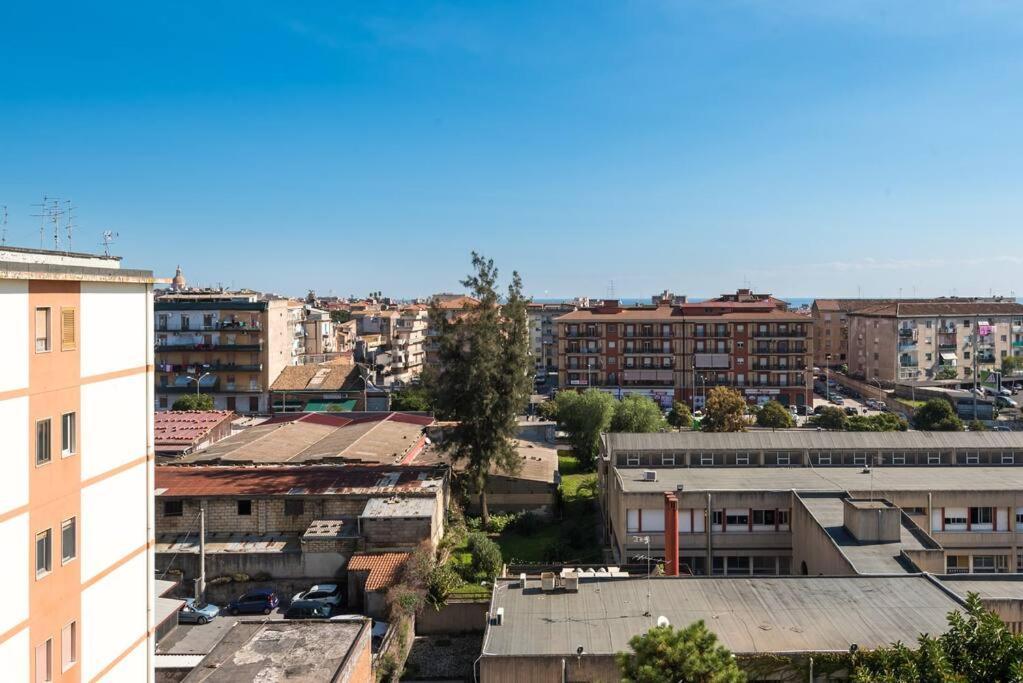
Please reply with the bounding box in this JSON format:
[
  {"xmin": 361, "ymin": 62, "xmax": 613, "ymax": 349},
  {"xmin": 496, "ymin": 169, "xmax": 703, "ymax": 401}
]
[{"xmin": 183, "ymin": 619, "xmax": 370, "ymax": 683}]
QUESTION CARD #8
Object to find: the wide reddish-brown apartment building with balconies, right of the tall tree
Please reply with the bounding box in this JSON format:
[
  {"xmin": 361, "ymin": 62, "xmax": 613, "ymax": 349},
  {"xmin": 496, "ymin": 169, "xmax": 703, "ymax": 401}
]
[{"xmin": 557, "ymin": 289, "xmax": 812, "ymax": 408}]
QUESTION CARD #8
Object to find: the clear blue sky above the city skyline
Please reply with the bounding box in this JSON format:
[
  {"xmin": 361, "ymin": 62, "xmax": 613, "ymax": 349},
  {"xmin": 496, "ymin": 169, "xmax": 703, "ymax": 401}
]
[{"xmin": 0, "ymin": 0, "xmax": 1023, "ymax": 298}]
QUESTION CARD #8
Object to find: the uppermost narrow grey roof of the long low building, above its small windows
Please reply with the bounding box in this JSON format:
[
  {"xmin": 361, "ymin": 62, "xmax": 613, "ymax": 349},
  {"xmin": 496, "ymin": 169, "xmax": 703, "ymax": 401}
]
[{"xmin": 603, "ymin": 429, "xmax": 1023, "ymax": 451}]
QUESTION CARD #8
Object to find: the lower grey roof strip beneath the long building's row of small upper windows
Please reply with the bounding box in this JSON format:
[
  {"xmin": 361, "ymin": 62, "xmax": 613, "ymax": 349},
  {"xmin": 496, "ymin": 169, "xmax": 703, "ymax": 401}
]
[{"xmin": 615, "ymin": 465, "xmax": 1023, "ymax": 493}]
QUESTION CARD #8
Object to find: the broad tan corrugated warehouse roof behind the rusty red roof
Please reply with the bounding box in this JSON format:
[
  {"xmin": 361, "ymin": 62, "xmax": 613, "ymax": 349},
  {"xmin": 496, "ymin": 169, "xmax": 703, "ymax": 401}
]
[{"xmin": 180, "ymin": 413, "xmax": 434, "ymax": 464}]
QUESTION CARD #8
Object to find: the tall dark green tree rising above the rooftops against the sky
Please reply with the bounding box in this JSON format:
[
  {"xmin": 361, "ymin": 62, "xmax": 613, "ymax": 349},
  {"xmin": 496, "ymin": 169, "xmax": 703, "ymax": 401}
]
[{"xmin": 428, "ymin": 252, "xmax": 533, "ymax": 525}]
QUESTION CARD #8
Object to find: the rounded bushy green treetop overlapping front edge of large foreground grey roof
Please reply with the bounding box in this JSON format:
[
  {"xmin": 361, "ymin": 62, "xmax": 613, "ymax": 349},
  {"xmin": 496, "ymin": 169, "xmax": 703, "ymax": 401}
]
[{"xmin": 615, "ymin": 620, "xmax": 746, "ymax": 683}]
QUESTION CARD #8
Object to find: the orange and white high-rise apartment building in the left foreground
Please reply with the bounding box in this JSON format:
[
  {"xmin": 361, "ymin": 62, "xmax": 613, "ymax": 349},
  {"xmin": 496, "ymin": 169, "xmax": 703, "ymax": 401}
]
[{"xmin": 0, "ymin": 246, "xmax": 154, "ymax": 681}]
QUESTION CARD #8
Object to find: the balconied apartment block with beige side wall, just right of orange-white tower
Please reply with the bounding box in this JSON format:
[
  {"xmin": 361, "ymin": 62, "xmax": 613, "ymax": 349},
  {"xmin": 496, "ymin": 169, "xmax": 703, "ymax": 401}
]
[{"xmin": 154, "ymin": 290, "xmax": 305, "ymax": 413}]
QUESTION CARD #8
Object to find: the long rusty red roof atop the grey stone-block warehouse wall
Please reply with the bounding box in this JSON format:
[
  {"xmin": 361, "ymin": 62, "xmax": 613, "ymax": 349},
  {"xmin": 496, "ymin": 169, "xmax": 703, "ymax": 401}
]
[{"xmin": 155, "ymin": 465, "xmax": 443, "ymax": 497}]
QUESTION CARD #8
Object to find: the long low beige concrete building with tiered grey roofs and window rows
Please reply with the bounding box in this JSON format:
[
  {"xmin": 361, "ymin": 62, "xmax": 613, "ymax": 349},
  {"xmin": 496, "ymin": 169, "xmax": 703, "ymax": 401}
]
[{"xmin": 598, "ymin": 430, "xmax": 1023, "ymax": 576}]
